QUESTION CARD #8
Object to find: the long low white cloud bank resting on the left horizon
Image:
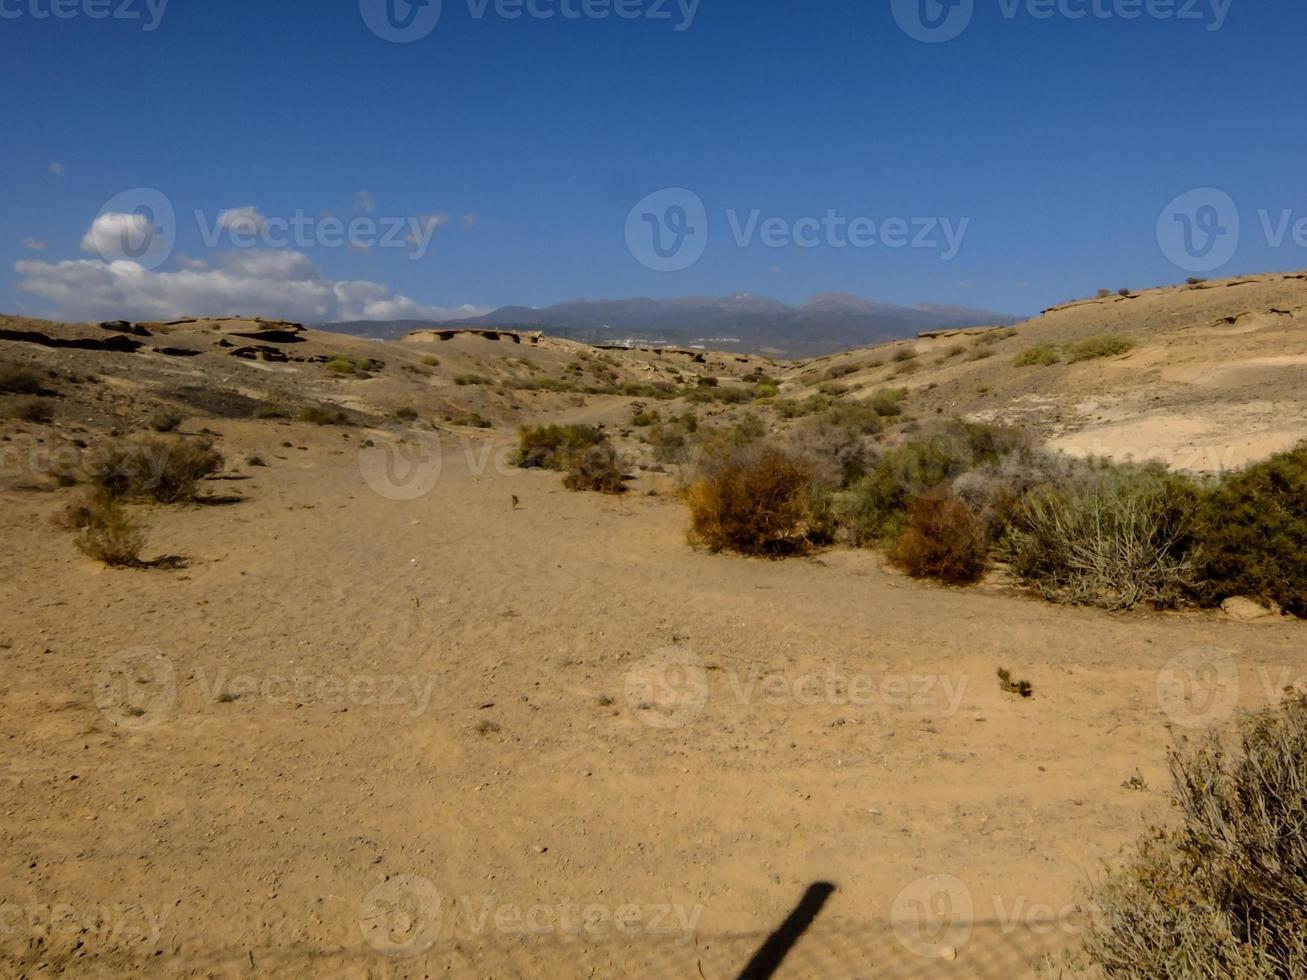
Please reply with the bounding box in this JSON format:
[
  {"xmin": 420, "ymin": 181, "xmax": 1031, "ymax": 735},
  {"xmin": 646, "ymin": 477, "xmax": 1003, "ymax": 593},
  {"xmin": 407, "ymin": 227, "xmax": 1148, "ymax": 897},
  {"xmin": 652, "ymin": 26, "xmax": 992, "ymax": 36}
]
[{"xmin": 14, "ymin": 250, "xmax": 486, "ymax": 323}]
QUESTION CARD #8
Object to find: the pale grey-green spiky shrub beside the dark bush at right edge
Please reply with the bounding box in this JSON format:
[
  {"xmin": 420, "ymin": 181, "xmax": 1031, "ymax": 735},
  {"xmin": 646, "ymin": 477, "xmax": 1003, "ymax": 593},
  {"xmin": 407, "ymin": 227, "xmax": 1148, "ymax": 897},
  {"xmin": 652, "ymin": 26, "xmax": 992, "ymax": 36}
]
[{"xmin": 1005, "ymin": 465, "xmax": 1200, "ymax": 609}]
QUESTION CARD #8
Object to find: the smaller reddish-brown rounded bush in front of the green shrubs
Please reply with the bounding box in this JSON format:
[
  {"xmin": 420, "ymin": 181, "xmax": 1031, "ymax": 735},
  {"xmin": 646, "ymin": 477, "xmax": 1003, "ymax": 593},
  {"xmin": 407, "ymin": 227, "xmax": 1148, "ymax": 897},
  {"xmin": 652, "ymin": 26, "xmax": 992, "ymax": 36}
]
[{"xmin": 890, "ymin": 495, "xmax": 988, "ymax": 585}]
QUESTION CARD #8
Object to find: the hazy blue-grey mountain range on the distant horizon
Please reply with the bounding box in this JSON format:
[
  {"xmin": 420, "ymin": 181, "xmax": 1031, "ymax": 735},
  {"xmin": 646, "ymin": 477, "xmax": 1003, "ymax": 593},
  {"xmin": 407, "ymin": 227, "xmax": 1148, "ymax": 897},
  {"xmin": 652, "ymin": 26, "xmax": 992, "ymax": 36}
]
[{"xmin": 323, "ymin": 293, "xmax": 1019, "ymax": 358}]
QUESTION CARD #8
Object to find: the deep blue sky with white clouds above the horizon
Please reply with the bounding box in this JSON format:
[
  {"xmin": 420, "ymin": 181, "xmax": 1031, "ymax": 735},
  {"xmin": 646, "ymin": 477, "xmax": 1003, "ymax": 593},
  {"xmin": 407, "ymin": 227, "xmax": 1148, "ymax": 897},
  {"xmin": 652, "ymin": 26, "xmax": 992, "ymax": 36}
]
[{"xmin": 0, "ymin": 0, "xmax": 1307, "ymax": 320}]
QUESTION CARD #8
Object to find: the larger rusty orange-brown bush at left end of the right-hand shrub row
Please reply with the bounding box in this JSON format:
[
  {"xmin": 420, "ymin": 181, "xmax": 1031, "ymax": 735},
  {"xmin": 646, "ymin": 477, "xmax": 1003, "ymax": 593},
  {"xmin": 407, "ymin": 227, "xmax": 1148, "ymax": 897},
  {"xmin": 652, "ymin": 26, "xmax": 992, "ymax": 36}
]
[{"xmin": 685, "ymin": 446, "xmax": 814, "ymax": 557}]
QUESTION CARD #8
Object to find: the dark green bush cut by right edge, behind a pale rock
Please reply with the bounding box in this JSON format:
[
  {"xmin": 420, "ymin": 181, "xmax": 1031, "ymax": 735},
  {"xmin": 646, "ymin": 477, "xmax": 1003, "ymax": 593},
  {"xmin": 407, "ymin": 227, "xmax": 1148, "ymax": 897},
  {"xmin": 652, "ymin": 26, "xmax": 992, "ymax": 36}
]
[{"xmin": 1199, "ymin": 446, "xmax": 1307, "ymax": 617}]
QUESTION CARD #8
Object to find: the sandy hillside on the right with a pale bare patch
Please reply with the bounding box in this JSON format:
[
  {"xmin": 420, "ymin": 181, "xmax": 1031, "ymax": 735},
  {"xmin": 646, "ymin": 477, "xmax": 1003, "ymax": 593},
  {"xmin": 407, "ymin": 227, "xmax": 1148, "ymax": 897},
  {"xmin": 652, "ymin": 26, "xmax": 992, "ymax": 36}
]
[{"xmin": 788, "ymin": 266, "xmax": 1307, "ymax": 472}]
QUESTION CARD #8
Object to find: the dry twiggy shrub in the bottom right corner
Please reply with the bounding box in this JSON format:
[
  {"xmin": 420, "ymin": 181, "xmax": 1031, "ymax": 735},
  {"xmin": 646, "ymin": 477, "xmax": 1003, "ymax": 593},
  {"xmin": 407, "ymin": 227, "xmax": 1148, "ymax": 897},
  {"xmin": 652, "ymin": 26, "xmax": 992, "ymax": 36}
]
[{"xmin": 1085, "ymin": 693, "xmax": 1307, "ymax": 980}]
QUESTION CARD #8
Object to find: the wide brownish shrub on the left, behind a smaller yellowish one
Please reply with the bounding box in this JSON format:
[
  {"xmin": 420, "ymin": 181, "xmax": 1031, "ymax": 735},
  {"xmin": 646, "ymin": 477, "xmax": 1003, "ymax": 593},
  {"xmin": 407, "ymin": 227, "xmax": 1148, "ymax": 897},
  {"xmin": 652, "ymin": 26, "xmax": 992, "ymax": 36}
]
[{"xmin": 91, "ymin": 439, "xmax": 223, "ymax": 503}]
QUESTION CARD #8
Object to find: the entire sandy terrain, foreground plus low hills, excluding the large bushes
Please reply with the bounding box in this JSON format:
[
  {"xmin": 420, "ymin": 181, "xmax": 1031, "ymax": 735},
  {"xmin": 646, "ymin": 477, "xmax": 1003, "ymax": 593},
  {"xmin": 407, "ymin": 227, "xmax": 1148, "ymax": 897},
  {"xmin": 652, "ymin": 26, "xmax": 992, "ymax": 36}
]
[{"xmin": 0, "ymin": 273, "xmax": 1307, "ymax": 980}]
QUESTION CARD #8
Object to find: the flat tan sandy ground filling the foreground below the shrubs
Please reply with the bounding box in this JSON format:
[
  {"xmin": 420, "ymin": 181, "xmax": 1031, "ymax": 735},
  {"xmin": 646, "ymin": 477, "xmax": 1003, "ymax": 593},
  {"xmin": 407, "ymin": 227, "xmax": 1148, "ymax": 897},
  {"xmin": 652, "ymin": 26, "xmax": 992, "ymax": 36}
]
[{"xmin": 0, "ymin": 422, "xmax": 1304, "ymax": 979}]
